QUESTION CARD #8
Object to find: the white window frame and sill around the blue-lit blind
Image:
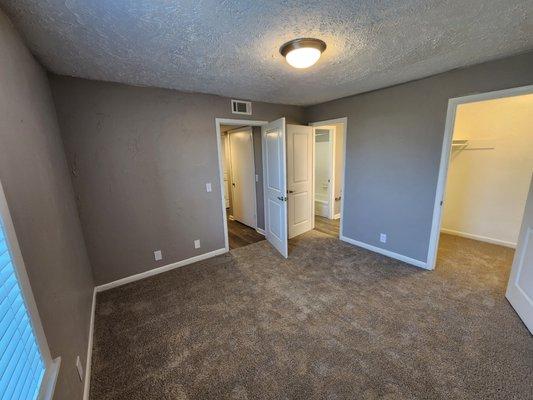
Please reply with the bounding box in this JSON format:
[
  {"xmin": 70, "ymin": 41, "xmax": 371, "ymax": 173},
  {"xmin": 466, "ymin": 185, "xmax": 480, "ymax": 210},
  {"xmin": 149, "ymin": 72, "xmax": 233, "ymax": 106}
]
[{"xmin": 0, "ymin": 182, "xmax": 61, "ymax": 400}]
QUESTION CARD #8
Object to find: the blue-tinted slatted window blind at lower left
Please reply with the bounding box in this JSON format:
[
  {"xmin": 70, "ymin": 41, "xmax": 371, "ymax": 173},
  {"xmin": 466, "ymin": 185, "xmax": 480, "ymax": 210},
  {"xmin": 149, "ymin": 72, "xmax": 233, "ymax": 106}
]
[{"xmin": 0, "ymin": 220, "xmax": 45, "ymax": 400}]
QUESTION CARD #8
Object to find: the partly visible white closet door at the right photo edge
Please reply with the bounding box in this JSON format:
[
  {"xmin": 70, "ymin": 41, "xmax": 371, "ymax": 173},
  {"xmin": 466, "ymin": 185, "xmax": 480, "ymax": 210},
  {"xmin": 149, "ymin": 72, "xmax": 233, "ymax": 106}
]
[{"xmin": 505, "ymin": 180, "xmax": 533, "ymax": 333}]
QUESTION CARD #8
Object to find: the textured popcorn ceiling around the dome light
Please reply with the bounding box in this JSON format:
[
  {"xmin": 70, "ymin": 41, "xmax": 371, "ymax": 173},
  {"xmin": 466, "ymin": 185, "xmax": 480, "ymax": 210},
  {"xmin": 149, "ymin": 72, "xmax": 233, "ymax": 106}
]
[{"xmin": 0, "ymin": 0, "xmax": 533, "ymax": 105}]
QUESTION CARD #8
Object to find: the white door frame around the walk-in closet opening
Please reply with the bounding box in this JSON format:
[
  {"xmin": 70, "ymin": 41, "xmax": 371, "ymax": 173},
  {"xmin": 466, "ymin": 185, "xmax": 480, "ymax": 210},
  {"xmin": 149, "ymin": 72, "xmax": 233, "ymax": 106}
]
[{"xmin": 426, "ymin": 85, "xmax": 533, "ymax": 269}]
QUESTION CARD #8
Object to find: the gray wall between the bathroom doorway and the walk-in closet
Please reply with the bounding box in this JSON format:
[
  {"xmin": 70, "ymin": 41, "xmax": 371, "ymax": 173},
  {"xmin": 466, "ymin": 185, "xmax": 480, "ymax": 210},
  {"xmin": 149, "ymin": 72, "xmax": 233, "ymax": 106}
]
[{"xmin": 306, "ymin": 53, "xmax": 533, "ymax": 261}]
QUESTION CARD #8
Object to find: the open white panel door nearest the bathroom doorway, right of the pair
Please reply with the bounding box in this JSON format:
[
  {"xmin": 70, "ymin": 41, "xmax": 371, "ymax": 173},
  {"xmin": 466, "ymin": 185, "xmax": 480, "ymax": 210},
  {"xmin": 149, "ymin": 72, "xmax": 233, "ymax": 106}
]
[{"xmin": 287, "ymin": 125, "xmax": 314, "ymax": 239}]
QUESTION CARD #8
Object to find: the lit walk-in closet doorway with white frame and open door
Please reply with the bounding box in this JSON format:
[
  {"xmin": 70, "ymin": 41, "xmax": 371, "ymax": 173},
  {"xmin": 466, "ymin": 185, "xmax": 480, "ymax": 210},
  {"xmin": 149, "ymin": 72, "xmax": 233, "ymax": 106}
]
[{"xmin": 427, "ymin": 86, "xmax": 533, "ymax": 330}]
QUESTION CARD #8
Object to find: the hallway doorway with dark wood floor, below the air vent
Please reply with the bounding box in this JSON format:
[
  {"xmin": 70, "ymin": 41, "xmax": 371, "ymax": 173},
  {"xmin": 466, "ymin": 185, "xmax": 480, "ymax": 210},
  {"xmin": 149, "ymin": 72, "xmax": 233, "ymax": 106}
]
[{"xmin": 216, "ymin": 119, "xmax": 266, "ymax": 250}]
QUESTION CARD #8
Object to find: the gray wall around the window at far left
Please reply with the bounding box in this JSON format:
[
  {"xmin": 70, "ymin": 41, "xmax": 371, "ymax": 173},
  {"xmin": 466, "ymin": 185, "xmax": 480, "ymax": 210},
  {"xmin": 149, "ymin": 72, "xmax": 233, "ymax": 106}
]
[{"xmin": 0, "ymin": 11, "xmax": 93, "ymax": 400}]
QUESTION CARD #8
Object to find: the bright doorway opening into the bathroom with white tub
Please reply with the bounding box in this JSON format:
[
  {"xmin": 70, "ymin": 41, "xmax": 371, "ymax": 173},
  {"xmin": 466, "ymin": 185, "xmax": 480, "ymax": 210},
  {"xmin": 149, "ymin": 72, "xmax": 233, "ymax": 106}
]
[{"xmin": 310, "ymin": 118, "xmax": 346, "ymax": 237}]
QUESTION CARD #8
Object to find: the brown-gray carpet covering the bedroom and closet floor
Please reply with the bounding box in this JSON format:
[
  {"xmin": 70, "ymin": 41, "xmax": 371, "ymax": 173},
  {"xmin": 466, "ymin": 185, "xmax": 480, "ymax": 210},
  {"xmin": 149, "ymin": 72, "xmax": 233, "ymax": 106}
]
[{"xmin": 91, "ymin": 231, "xmax": 533, "ymax": 400}]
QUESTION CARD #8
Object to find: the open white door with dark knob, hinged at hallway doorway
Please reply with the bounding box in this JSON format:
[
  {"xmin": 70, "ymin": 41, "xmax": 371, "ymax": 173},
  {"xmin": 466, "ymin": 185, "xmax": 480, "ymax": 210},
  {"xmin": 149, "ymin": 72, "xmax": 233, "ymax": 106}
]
[{"xmin": 261, "ymin": 118, "xmax": 289, "ymax": 258}]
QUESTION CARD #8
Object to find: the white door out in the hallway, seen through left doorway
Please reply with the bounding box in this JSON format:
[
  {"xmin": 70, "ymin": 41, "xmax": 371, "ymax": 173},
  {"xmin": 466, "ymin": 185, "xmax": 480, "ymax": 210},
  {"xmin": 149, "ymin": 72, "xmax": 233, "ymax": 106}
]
[{"xmin": 228, "ymin": 127, "xmax": 257, "ymax": 228}]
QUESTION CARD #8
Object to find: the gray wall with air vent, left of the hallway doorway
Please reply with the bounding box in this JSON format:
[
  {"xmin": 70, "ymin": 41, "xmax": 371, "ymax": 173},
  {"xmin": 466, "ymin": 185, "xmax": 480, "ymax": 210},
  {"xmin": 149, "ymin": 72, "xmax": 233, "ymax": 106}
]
[{"xmin": 49, "ymin": 75, "xmax": 303, "ymax": 284}]
